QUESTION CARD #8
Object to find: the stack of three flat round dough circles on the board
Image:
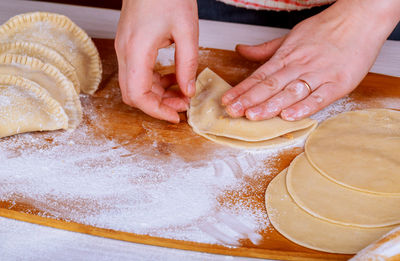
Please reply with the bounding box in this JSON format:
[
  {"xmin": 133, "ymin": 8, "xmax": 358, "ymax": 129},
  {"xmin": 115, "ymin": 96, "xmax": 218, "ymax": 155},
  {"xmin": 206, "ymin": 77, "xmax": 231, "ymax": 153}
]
[{"xmin": 266, "ymin": 109, "xmax": 400, "ymax": 254}]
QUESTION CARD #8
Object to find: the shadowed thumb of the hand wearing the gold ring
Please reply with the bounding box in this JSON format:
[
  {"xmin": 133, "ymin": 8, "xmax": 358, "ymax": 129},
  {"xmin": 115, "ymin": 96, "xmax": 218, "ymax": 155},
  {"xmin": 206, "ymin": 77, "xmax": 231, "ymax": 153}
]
[{"xmin": 236, "ymin": 37, "xmax": 285, "ymax": 62}]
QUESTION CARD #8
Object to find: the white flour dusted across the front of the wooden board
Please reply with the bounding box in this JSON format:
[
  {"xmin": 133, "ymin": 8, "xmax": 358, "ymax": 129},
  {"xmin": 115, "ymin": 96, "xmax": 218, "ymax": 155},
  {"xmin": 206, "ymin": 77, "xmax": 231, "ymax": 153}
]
[{"xmin": 0, "ymin": 96, "xmax": 288, "ymax": 246}]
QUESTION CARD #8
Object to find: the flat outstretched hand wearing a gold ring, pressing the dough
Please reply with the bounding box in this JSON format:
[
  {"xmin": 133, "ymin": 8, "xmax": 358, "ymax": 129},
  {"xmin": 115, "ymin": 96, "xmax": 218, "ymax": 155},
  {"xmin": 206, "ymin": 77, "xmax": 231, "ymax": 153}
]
[{"xmin": 222, "ymin": 0, "xmax": 400, "ymax": 121}]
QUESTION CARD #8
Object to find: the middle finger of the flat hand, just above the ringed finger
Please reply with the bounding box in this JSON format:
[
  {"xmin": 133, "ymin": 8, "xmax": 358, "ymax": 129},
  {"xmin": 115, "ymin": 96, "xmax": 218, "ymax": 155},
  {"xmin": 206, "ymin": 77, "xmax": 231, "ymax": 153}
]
[{"xmin": 226, "ymin": 66, "xmax": 300, "ymax": 117}]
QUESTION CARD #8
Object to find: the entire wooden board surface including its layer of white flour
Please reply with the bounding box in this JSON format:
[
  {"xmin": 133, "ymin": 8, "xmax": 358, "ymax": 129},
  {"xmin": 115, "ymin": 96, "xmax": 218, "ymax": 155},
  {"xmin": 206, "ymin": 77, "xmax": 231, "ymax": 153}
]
[{"xmin": 0, "ymin": 40, "xmax": 400, "ymax": 260}]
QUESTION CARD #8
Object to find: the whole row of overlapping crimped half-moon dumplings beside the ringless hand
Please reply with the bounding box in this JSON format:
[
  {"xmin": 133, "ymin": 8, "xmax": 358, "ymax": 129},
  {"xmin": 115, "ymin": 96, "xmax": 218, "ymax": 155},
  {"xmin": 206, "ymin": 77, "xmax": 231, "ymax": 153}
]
[{"xmin": 0, "ymin": 12, "xmax": 102, "ymax": 137}]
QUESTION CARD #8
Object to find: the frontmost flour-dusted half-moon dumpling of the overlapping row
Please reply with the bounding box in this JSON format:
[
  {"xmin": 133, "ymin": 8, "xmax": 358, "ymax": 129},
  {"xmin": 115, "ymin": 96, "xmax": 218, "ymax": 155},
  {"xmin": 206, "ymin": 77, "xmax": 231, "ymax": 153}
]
[{"xmin": 0, "ymin": 74, "xmax": 68, "ymax": 138}]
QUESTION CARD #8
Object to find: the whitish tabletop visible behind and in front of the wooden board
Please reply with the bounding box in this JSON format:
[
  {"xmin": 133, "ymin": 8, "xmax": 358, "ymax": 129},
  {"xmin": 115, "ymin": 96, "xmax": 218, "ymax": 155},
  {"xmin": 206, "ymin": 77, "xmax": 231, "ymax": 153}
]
[{"xmin": 0, "ymin": 0, "xmax": 400, "ymax": 261}]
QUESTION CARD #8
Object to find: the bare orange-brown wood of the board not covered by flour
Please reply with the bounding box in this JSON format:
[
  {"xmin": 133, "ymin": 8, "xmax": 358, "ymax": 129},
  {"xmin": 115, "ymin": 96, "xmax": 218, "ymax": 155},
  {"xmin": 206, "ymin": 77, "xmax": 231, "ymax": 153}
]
[{"xmin": 0, "ymin": 39, "xmax": 400, "ymax": 260}]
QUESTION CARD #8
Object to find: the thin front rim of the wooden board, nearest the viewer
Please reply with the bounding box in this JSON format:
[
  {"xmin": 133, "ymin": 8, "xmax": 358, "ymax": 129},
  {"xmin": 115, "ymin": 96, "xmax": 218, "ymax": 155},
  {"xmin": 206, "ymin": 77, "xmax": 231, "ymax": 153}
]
[{"xmin": 0, "ymin": 208, "xmax": 350, "ymax": 261}]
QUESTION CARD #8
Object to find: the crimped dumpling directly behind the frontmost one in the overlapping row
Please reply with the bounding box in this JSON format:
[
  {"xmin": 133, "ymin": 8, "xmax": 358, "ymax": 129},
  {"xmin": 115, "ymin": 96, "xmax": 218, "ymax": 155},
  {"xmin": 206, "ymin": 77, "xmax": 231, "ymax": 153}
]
[{"xmin": 0, "ymin": 54, "xmax": 82, "ymax": 129}]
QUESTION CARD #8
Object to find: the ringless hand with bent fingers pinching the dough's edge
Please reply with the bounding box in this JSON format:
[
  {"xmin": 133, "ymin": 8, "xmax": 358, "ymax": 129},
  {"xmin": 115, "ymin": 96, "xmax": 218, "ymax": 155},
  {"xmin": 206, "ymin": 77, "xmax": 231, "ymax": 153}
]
[{"xmin": 115, "ymin": 0, "xmax": 198, "ymax": 123}]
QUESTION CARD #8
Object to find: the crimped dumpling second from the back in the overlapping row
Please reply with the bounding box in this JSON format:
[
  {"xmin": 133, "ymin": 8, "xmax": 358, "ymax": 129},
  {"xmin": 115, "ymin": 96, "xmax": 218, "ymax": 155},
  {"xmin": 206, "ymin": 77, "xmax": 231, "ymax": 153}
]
[{"xmin": 0, "ymin": 42, "xmax": 80, "ymax": 94}]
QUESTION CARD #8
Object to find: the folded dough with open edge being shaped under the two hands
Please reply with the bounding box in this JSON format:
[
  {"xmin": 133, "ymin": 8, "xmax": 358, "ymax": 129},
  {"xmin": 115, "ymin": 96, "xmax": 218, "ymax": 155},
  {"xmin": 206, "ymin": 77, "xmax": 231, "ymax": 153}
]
[{"xmin": 188, "ymin": 68, "xmax": 317, "ymax": 148}]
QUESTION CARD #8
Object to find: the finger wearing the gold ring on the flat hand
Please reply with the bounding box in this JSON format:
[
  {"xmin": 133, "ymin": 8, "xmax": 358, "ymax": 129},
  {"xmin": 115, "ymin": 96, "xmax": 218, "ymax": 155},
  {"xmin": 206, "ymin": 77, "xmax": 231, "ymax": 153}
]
[{"xmin": 246, "ymin": 80, "xmax": 310, "ymax": 120}]
